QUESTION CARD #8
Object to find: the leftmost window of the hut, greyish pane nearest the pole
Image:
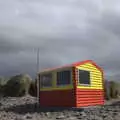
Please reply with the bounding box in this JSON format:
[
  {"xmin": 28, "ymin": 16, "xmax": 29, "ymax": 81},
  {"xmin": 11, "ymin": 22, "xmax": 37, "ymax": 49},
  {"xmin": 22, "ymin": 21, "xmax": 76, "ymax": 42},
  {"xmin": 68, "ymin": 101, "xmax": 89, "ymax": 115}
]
[{"xmin": 40, "ymin": 74, "xmax": 52, "ymax": 87}]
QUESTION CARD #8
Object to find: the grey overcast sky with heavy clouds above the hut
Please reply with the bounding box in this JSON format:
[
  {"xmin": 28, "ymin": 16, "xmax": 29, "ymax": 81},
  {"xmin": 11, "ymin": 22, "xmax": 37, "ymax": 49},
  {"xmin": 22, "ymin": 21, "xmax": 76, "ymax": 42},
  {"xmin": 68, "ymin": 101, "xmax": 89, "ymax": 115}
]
[{"xmin": 0, "ymin": 0, "xmax": 120, "ymax": 77}]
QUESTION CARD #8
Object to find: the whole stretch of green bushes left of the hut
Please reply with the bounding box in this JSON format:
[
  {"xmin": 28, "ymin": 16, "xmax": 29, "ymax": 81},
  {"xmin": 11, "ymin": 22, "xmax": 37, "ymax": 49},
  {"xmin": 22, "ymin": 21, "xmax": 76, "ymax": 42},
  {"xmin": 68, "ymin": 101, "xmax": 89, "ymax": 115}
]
[{"xmin": 0, "ymin": 74, "xmax": 37, "ymax": 97}]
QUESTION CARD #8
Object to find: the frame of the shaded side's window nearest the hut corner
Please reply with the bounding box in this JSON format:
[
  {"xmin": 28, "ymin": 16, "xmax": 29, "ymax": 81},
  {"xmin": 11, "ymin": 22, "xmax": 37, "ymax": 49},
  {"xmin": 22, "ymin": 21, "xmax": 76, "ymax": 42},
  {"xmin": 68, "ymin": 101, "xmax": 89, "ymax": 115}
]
[{"xmin": 56, "ymin": 69, "xmax": 73, "ymax": 87}]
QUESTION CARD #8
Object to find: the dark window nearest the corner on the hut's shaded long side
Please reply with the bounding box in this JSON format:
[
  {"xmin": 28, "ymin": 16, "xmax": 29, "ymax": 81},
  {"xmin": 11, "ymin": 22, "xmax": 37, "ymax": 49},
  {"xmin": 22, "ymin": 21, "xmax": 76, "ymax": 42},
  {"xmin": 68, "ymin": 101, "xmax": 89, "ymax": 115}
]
[{"xmin": 57, "ymin": 70, "xmax": 71, "ymax": 86}]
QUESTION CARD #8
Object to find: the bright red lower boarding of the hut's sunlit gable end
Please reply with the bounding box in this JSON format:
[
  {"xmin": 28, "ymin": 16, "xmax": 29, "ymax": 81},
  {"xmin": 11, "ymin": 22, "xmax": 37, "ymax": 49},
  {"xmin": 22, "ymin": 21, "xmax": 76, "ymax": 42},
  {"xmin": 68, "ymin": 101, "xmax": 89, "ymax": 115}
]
[{"xmin": 76, "ymin": 88, "xmax": 104, "ymax": 107}]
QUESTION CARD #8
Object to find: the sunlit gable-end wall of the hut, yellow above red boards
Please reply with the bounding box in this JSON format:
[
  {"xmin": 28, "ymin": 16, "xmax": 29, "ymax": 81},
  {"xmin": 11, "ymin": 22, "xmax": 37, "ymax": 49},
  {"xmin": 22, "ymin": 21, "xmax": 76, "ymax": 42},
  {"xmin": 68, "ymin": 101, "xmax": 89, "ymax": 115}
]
[{"xmin": 75, "ymin": 63, "xmax": 104, "ymax": 107}]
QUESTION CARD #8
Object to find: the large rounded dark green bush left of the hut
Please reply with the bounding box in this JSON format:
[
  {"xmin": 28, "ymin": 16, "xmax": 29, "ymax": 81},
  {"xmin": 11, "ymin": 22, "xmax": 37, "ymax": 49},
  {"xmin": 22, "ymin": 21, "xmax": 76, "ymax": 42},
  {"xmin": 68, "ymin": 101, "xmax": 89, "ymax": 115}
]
[{"xmin": 2, "ymin": 74, "xmax": 31, "ymax": 97}]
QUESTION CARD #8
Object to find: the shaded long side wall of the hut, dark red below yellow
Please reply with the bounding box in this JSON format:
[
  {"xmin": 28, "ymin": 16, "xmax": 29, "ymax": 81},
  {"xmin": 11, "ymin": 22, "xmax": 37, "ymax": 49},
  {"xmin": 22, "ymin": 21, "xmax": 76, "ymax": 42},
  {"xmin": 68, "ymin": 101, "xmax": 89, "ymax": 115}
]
[{"xmin": 40, "ymin": 68, "xmax": 76, "ymax": 107}]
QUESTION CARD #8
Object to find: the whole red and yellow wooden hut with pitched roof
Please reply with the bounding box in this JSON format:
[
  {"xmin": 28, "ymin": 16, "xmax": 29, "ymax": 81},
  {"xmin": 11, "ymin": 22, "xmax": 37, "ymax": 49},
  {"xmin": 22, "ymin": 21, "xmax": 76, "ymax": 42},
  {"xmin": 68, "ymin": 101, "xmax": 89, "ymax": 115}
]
[{"xmin": 39, "ymin": 60, "xmax": 104, "ymax": 107}]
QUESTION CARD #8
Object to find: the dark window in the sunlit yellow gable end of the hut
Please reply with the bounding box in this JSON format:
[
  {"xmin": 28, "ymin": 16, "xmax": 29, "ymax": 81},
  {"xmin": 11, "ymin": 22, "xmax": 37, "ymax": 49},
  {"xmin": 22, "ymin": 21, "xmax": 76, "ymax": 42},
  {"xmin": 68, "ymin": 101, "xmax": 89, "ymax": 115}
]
[{"xmin": 78, "ymin": 70, "xmax": 90, "ymax": 85}]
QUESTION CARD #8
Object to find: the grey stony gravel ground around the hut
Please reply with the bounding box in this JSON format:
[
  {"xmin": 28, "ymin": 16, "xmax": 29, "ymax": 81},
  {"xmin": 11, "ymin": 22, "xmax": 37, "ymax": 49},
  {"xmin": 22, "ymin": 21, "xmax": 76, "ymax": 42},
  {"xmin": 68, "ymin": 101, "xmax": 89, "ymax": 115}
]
[{"xmin": 0, "ymin": 95, "xmax": 120, "ymax": 120}]
